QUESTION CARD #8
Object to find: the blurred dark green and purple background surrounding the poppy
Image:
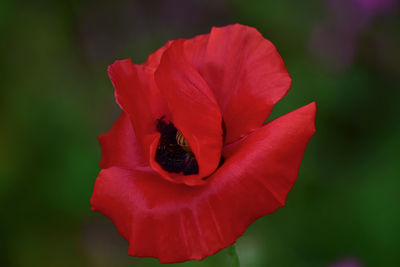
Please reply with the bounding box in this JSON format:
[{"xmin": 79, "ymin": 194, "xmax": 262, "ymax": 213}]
[{"xmin": 0, "ymin": 0, "xmax": 400, "ymax": 267}]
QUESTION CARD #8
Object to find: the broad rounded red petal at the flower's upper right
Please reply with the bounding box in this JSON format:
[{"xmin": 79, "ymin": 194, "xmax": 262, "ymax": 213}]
[{"xmin": 185, "ymin": 24, "xmax": 291, "ymax": 144}]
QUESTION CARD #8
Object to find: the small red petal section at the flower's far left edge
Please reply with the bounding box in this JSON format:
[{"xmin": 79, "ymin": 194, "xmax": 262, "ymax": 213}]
[{"xmin": 99, "ymin": 112, "xmax": 149, "ymax": 169}]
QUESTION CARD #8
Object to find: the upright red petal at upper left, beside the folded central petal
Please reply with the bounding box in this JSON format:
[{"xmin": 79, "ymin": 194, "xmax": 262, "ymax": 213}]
[{"xmin": 108, "ymin": 43, "xmax": 170, "ymax": 163}]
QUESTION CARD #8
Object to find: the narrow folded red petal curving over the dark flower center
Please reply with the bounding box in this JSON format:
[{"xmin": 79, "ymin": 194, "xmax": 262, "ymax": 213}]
[{"xmin": 155, "ymin": 40, "xmax": 223, "ymax": 182}]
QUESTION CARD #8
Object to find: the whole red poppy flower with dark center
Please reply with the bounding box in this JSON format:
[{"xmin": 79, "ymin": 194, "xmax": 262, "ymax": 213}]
[{"xmin": 91, "ymin": 25, "xmax": 316, "ymax": 263}]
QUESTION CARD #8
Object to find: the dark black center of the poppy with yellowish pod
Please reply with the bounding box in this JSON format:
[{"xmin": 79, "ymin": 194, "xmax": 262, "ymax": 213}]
[{"xmin": 156, "ymin": 119, "xmax": 199, "ymax": 175}]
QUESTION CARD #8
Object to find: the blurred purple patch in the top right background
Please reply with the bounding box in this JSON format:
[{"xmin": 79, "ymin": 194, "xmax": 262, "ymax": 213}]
[{"xmin": 310, "ymin": 0, "xmax": 397, "ymax": 70}]
